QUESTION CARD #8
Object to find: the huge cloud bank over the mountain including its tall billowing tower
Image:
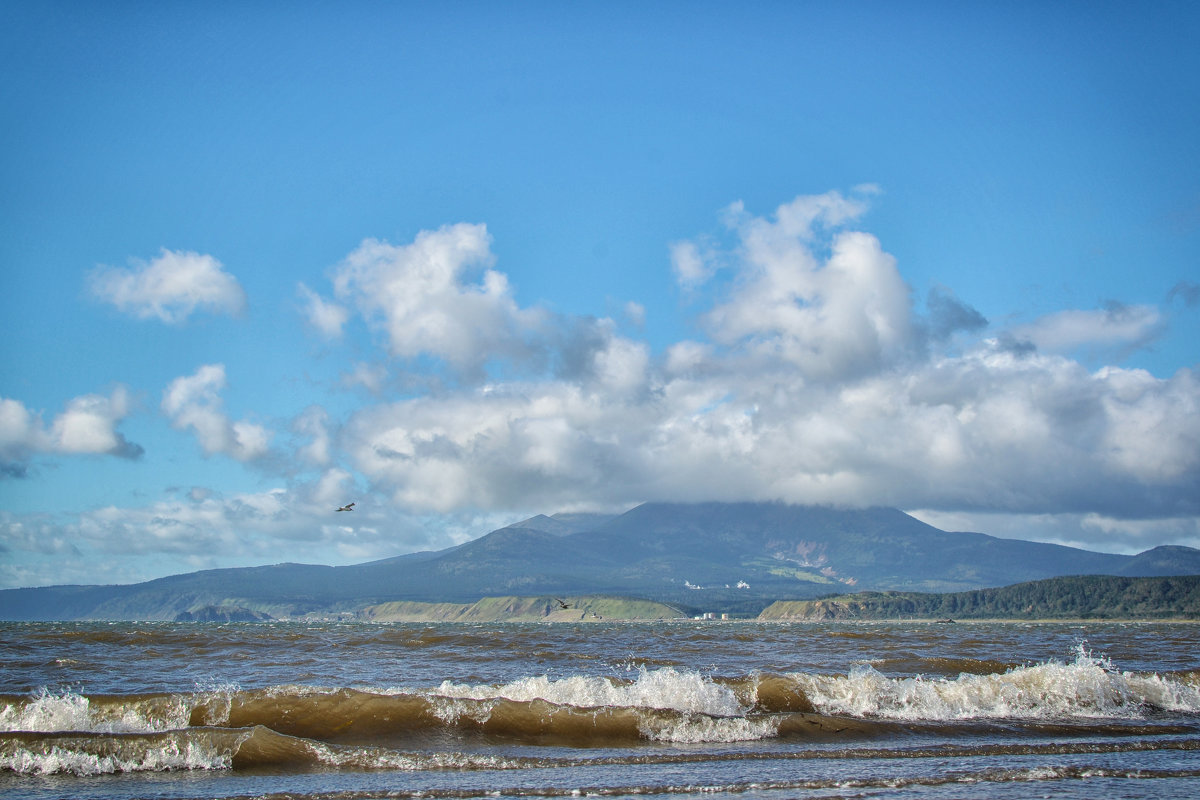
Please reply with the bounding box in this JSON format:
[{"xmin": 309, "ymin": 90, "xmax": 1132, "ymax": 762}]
[{"xmin": 333, "ymin": 193, "xmax": 1200, "ymax": 532}]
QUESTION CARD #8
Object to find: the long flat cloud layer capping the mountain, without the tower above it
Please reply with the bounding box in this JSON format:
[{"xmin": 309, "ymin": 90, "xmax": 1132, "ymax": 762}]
[{"xmin": 347, "ymin": 350, "xmax": 1200, "ymax": 517}]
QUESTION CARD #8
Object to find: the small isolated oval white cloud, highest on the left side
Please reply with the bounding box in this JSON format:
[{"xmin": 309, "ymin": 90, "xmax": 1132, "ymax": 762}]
[{"xmin": 89, "ymin": 248, "xmax": 246, "ymax": 323}]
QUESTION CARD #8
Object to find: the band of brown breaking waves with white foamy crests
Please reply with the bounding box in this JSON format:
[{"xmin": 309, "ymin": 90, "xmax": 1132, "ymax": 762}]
[{"xmin": 0, "ymin": 646, "xmax": 1200, "ymax": 775}]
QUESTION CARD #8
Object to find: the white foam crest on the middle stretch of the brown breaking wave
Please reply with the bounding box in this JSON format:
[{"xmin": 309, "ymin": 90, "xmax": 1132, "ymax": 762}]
[{"xmin": 432, "ymin": 667, "xmax": 746, "ymax": 717}]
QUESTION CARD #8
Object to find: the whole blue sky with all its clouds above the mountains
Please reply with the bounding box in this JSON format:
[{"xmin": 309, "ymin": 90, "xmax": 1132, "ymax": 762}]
[{"xmin": 0, "ymin": 0, "xmax": 1200, "ymax": 588}]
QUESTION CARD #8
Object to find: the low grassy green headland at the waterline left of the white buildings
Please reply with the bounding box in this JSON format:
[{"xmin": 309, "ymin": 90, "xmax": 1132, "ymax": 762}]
[{"xmin": 358, "ymin": 596, "xmax": 685, "ymax": 622}]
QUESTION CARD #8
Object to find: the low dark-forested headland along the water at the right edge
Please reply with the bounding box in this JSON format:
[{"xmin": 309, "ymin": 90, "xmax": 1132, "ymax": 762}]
[{"xmin": 758, "ymin": 575, "xmax": 1200, "ymax": 621}]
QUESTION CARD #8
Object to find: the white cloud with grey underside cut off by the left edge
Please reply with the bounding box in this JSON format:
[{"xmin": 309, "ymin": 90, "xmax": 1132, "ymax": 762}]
[{"xmin": 0, "ymin": 386, "xmax": 144, "ymax": 476}]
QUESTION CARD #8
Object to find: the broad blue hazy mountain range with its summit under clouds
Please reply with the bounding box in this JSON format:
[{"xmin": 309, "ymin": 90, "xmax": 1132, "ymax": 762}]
[{"xmin": 0, "ymin": 503, "xmax": 1200, "ymax": 620}]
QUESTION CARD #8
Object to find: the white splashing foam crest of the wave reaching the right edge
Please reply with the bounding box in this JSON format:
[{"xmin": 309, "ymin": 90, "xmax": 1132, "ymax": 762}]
[{"xmin": 793, "ymin": 645, "xmax": 1200, "ymax": 721}]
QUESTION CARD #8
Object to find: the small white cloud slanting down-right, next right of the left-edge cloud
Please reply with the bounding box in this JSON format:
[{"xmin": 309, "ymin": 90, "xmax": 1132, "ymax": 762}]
[{"xmin": 162, "ymin": 363, "xmax": 271, "ymax": 461}]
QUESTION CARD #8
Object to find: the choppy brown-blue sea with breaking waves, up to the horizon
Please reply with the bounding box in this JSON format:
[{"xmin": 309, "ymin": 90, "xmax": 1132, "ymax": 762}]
[{"xmin": 0, "ymin": 620, "xmax": 1200, "ymax": 800}]
